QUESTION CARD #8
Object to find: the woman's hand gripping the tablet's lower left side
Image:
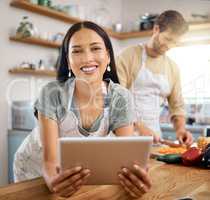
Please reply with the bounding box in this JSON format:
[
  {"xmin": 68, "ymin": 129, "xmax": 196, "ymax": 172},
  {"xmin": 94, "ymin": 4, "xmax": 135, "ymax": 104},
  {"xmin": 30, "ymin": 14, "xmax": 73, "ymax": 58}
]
[{"xmin": 45, "ymin": 166, "xmax": 90, "ymax": 197}]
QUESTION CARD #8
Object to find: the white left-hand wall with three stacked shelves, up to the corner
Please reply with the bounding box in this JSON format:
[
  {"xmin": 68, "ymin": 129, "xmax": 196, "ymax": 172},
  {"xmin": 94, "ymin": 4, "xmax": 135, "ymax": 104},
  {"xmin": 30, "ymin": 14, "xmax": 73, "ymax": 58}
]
[{"xmin": 0, "ymin": 0, "xmax": 121, "ymax": 186}]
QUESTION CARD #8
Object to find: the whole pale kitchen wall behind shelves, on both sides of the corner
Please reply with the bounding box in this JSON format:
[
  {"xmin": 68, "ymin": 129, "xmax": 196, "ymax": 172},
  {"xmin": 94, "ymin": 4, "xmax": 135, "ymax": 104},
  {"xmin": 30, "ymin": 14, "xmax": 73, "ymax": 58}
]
[{"xmin": 0, "ymin": 0, "xmax": 210, "ymax": 185}]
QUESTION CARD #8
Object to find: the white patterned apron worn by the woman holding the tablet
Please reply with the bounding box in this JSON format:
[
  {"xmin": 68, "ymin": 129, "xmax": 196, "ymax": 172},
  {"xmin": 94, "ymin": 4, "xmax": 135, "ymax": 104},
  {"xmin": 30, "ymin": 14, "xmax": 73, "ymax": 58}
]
[{"xmin": 13, "ymin": 82, "xmax": 109, "ymax": 182}]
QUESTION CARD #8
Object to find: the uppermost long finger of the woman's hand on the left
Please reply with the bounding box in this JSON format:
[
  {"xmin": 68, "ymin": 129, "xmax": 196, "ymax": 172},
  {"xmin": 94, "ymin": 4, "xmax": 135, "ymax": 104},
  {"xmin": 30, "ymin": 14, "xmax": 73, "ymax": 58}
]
[{"xmin": 52, "ymin": 166, "xmax": 82, "ymax": 186}]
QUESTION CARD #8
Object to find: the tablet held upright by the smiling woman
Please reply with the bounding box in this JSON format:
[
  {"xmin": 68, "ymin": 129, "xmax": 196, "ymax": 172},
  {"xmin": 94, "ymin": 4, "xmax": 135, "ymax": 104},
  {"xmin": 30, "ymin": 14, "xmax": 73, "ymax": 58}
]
[{"xmin": 58, "ymin": 136, "xmax": 153, "ymax": 185}]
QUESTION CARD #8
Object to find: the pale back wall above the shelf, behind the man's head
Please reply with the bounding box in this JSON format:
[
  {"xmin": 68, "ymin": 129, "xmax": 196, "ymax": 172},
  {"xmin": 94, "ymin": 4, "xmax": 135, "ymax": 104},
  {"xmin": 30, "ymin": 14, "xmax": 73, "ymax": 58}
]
[{"xmin": 122, "ymin": 0, "xmax": 210, "ymax": 29}]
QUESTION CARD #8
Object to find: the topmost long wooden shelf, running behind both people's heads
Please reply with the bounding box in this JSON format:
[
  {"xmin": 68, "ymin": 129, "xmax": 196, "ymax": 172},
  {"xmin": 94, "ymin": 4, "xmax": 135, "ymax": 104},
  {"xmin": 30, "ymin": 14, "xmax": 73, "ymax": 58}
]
[{"xmin": 10, "ymin": 0, "xmax": 210, "ymax": 40}]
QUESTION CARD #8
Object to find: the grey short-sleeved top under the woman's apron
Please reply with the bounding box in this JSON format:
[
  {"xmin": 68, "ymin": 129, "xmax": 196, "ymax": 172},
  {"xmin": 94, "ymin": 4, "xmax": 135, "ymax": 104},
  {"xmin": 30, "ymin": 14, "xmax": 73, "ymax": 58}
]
[{"xmin": 35, "ymin": 78, "xmax": 135, "ymax": 134}]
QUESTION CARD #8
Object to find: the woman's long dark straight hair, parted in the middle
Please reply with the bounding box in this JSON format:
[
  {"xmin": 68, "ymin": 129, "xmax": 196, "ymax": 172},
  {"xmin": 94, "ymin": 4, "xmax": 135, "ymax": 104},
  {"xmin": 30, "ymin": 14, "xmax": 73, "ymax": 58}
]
[{"xmin": 56, "ymin": 21, "xmax": 119, "ymax": 83}]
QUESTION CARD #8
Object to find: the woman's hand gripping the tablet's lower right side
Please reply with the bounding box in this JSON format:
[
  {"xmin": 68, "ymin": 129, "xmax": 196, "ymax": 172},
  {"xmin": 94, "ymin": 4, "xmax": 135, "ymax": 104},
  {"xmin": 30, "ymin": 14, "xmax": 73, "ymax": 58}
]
[{"xmin": 118, "ymin": 164, "xmax": 151, "ymax": 198}]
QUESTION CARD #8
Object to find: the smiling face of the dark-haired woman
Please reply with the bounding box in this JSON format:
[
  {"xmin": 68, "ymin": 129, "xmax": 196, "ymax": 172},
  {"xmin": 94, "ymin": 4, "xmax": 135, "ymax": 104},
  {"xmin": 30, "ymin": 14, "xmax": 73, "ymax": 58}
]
[{"xmin": 68, "ymin": 28, "xmax": 110, "ymax": 82}]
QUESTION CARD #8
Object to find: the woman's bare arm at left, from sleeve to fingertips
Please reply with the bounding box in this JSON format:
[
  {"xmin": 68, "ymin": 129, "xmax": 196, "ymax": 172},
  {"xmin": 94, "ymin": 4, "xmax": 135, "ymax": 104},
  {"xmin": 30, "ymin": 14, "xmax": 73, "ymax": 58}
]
[{"xmin": 39, "ymin": 113, "xmax": 90, "ymax": 197}]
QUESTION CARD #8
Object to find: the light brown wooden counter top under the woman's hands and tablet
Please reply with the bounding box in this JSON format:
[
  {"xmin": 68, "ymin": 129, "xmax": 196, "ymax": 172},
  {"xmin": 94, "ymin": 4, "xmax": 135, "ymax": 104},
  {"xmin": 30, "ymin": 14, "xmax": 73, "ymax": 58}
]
[{"xmin": 0, "ymin": 159, "xmax": 210, "ymax": 200}]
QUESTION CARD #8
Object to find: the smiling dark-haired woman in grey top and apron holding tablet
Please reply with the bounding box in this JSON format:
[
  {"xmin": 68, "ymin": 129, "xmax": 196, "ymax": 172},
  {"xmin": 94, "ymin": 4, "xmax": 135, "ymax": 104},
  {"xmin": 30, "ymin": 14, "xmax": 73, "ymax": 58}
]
[{"xmin": 14, "ymin": 22, "xmax": 151, "ymax": 197}]
